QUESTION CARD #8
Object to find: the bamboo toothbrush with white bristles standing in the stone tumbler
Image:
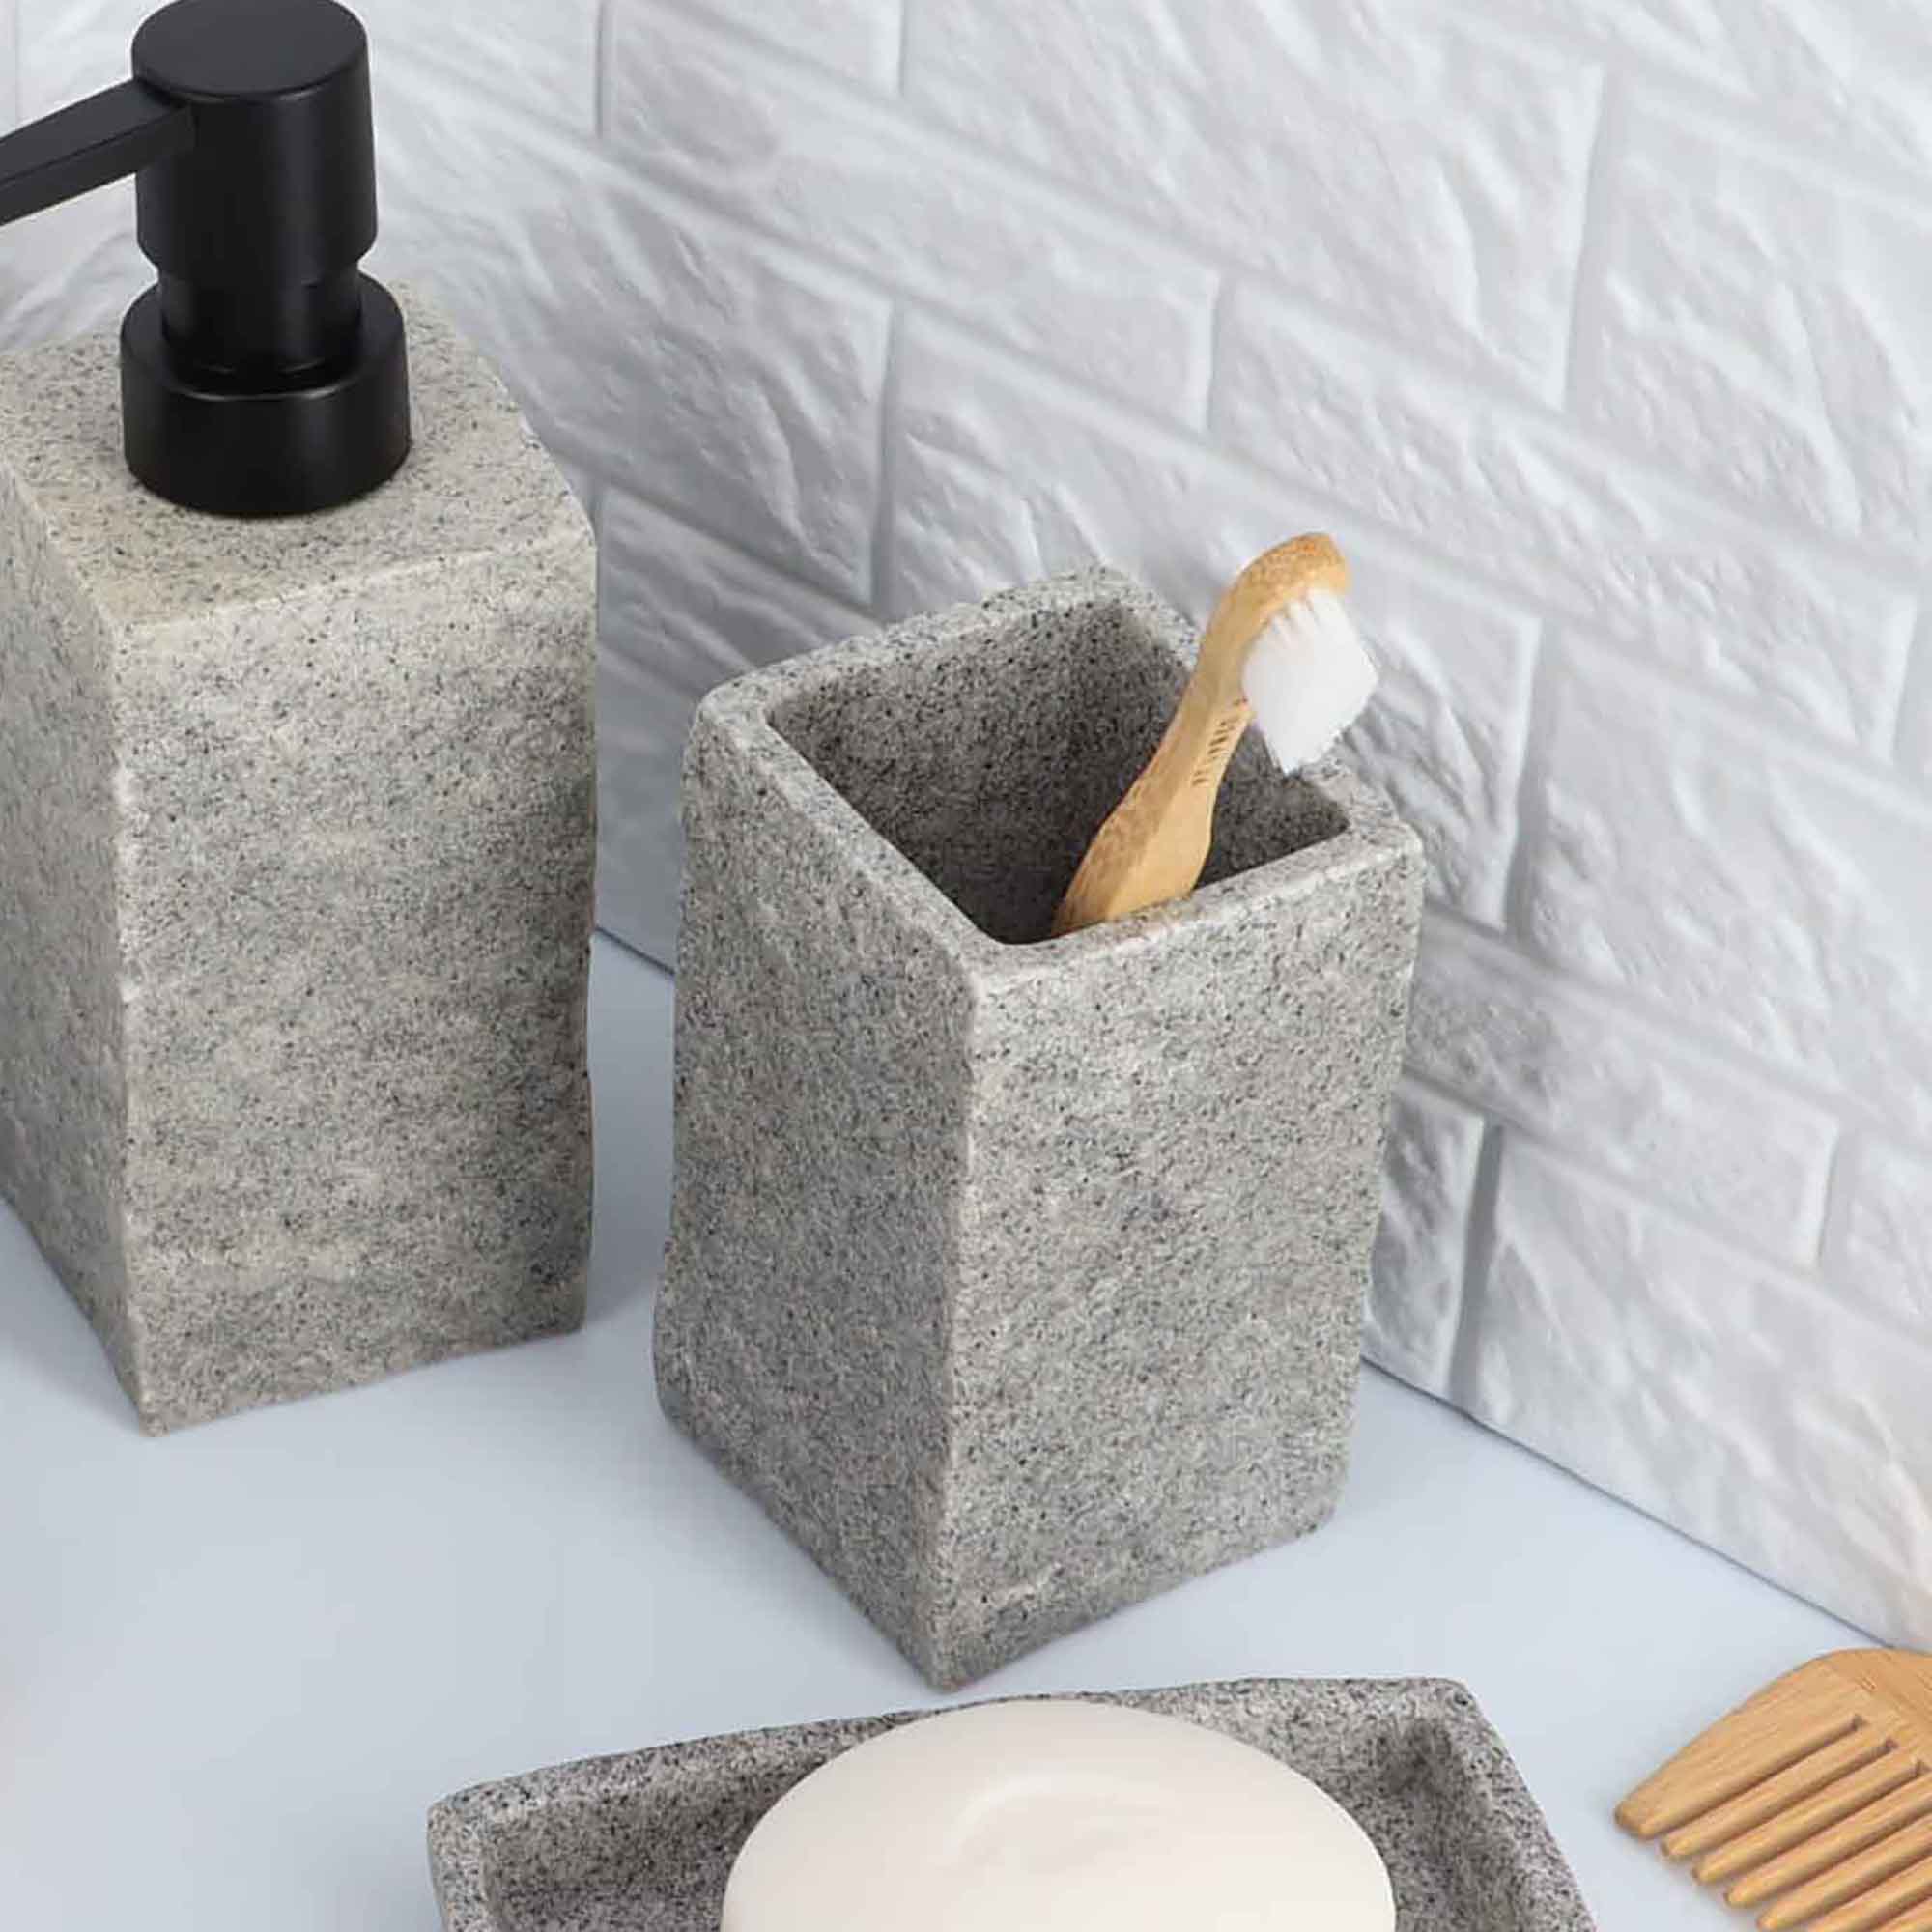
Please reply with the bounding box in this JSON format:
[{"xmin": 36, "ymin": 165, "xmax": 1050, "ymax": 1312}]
[{"xmin": 1053, "ymin": 535, "xmax": 1376, "ymax": 939}]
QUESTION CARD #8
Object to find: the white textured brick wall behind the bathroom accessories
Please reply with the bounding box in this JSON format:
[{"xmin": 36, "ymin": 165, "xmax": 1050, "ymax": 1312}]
[{"xmin": 0, "ymin": 0, "xmax": 1932, "ymax": 1642}]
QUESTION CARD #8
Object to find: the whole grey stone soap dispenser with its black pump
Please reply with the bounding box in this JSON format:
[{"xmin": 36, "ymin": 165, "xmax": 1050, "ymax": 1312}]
[{"xmin": 0, "ymin": 0, "xmax": 595, "ymax": 1430}]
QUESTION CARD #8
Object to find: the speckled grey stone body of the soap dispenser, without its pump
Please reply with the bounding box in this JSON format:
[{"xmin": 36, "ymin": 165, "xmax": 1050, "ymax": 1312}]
[{"xmin": 0, "ymin": 296, "xmax": 595, "ymax": 1430}]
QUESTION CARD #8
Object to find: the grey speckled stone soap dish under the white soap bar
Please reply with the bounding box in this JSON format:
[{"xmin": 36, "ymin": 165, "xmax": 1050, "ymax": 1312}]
[{"xmin": 429, "ymin": 1677, "xmax": 1592, "ymax": 1932}]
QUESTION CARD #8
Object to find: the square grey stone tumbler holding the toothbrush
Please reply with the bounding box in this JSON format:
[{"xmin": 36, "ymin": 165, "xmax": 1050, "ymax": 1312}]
[{"xmin": 657, "ymin": 572, "xmax": 1422, "ymax": 1689}]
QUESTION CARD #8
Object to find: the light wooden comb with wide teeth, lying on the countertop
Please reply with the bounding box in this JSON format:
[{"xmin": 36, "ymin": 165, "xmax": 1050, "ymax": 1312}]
[{"xmin": 1617, "ymin": 1650, "xmax": 1932, "ymax": 1932}]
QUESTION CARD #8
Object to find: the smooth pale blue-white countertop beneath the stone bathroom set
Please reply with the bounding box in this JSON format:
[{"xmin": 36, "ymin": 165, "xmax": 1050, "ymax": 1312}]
[{"xmin": 0, "ymin": 941, "xmax": 1859, "ymax": 1932}]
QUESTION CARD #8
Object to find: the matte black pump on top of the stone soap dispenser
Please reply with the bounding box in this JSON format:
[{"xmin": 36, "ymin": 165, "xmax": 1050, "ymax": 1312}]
[{"xmin": 0, "ymin": 0, "xmax": 410, "ymax": 516}]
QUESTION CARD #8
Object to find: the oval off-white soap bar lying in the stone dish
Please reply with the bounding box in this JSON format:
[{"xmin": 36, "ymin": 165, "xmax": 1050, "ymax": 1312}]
[{"xmin": 723, "ymin": 1702, "xmax": 1395, "ymax": 1932}]
